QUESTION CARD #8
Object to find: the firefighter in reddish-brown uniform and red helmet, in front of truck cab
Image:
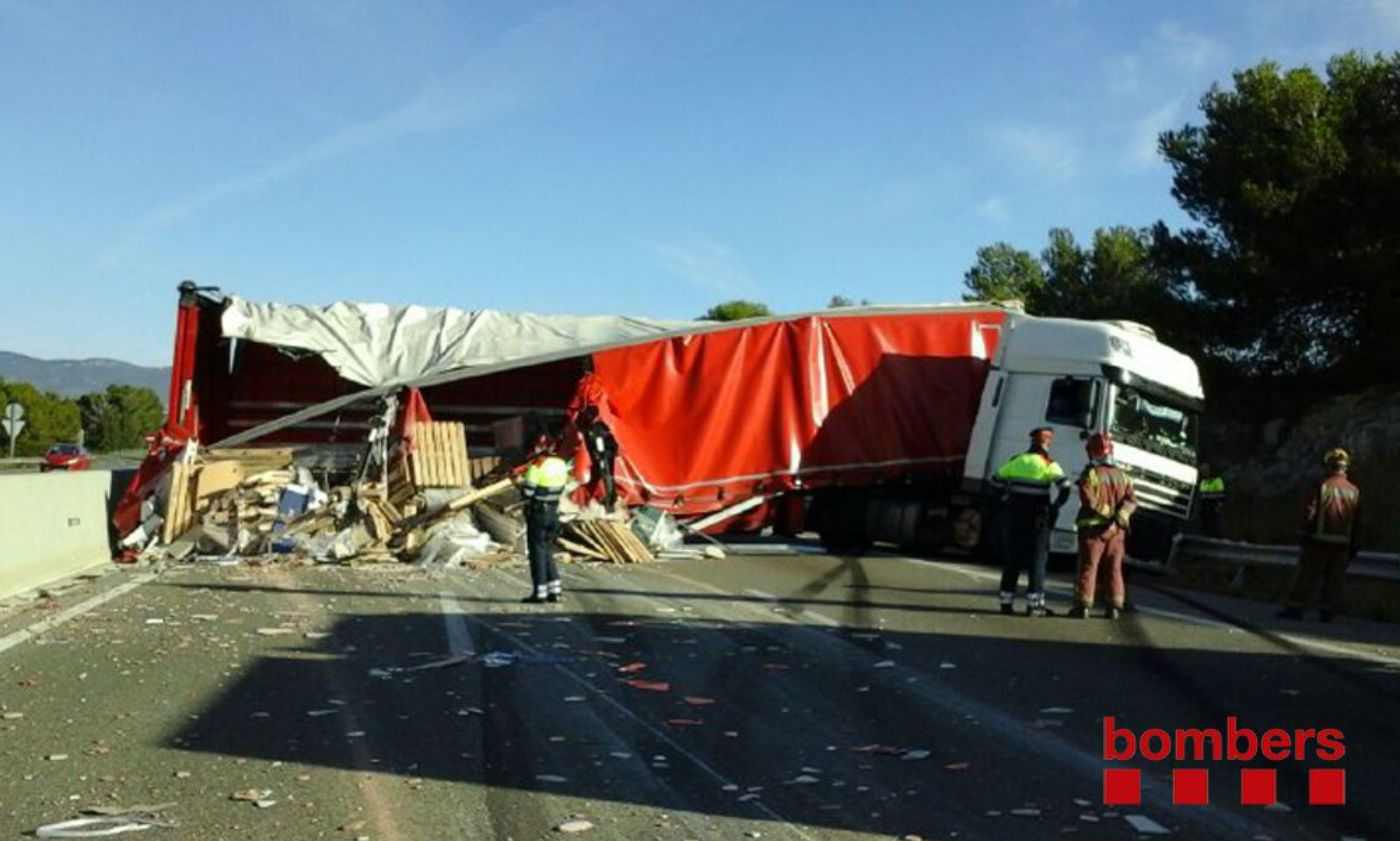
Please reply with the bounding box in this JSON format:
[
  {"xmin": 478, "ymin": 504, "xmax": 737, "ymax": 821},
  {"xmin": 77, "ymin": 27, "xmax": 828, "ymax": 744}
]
[{"xmin": 1070, "ymin": 432, "xmax": 1137, "ymax": 619}]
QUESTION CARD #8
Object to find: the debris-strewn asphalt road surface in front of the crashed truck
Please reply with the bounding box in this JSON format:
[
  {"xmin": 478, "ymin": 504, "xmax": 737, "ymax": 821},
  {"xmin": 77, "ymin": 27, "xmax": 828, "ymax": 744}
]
[{"xmin": 0, "ymin": 553, "xmax": 1400, "ymax": 841}]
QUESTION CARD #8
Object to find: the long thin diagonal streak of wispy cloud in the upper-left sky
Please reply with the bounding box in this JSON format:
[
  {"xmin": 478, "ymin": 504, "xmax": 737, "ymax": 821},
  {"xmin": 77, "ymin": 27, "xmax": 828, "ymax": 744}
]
[{"xmin": 99, "ymin": 6, "xmax": 638, "ymax": 263}]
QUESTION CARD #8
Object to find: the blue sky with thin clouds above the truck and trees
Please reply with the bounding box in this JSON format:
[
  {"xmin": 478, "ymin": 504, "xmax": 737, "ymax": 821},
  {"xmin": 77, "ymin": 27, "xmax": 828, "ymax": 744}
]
[{"xmin": 0, "ymin": 0, "xmax": 1400, "ymax": 364}]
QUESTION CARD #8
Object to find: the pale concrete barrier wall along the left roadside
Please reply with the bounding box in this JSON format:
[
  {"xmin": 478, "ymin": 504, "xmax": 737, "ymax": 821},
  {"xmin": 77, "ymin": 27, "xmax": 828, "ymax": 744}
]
[{"xmin": 0, "ymin": 470, "xmax": 116, "ymax": 599}]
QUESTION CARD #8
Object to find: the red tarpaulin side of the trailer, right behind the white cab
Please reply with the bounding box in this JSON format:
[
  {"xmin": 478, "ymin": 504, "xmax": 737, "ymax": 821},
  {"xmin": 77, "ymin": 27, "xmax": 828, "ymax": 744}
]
[{"xmin": 578, "ymin": 309, "xmax": 1005, "ymax": 514}]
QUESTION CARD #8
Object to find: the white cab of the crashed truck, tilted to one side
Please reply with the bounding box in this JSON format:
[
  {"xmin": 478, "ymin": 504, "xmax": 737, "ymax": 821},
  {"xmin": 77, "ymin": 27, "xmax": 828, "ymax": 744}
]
[{"xmin": 965, "ymin": 315, "xmax": 1204, "ymax": 560}]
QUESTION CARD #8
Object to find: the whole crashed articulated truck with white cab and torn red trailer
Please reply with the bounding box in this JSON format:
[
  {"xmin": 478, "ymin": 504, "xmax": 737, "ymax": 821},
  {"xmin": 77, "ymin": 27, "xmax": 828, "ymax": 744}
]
[{"xmin": 116, "ymin": 284, "xmax": 1203, "ymax": 557}]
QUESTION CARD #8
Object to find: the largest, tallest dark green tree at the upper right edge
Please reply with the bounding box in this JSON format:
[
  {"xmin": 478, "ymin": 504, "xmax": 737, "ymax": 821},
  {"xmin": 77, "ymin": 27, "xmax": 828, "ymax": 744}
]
[{"xmin": 1154, "ymin": 53, "xmax": 1400, "ymax": 388}]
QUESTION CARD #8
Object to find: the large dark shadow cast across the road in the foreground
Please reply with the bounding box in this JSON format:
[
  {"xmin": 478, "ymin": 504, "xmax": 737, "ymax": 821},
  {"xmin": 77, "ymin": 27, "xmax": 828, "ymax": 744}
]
[{"xmin": 168, "ymin": 588, "xmax": 1400, "ymax": 838}]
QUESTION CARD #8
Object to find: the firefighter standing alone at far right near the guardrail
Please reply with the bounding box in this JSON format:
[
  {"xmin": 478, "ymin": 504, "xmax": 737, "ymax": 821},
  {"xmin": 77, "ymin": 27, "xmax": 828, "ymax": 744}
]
[{"xmin": 1278, "ymin": 449, "xmax": 1361, "ymax": 621}]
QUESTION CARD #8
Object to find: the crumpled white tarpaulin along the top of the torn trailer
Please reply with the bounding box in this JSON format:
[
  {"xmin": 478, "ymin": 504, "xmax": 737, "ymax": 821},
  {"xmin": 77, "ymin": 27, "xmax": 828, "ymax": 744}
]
[{"xmin": 223, "ymin": 297, "xmax": 694, "ymax": 386}]
